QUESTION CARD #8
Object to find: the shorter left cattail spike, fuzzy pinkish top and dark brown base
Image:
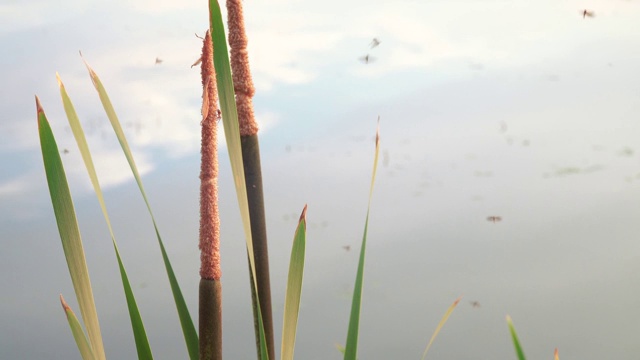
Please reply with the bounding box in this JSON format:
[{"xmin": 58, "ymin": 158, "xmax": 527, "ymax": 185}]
[{"xmin": 199, "ymin": 31, "xmax": 222, "ymax": 359}]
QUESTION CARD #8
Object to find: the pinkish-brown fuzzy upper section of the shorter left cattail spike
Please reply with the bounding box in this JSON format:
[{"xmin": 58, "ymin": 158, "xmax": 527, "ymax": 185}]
[{"xmin": 199, "ymin": 31, "xmax": 222, "ymax": 280}]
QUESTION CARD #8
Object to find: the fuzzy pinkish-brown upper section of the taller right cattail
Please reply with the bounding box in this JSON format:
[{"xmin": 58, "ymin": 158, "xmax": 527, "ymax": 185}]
[{"xmin": 227, "ymin": 0, "xmax": 258, "ymax": 136}]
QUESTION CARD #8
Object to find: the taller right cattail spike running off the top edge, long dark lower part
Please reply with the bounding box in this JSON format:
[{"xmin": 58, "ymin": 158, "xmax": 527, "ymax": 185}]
[{"xmin": 226, "ymin": 0, "xmax": 275, "ymax": 359}]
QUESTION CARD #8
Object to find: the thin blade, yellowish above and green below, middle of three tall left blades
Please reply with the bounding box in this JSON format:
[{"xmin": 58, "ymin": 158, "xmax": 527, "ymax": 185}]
[{"xmin": 56, "ymin": 74, "xmax": 153, "ymax": 359}]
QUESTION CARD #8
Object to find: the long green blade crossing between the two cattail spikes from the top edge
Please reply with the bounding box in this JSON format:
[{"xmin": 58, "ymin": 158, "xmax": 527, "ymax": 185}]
[{"xmin": 209, "ymin": 0, "xmax": 268, "ymax": 360}]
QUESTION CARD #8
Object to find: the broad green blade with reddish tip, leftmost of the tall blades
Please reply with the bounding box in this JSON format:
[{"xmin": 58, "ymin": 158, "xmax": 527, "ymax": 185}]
[{"xmin": 36, "ymin": 97, "xmax": 105, "ymax": 360}]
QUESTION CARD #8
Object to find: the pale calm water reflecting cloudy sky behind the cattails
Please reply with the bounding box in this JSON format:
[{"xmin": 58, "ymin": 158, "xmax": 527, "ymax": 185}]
[{"xmin": 0, "ymin": 0, "xmax": 640, "ymax": 359}]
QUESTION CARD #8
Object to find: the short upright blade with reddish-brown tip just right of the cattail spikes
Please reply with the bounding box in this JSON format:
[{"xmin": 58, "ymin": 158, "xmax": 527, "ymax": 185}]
[{"xmin": 280, "ymin": 205, "xmax": 307, "ymax": 360}]
